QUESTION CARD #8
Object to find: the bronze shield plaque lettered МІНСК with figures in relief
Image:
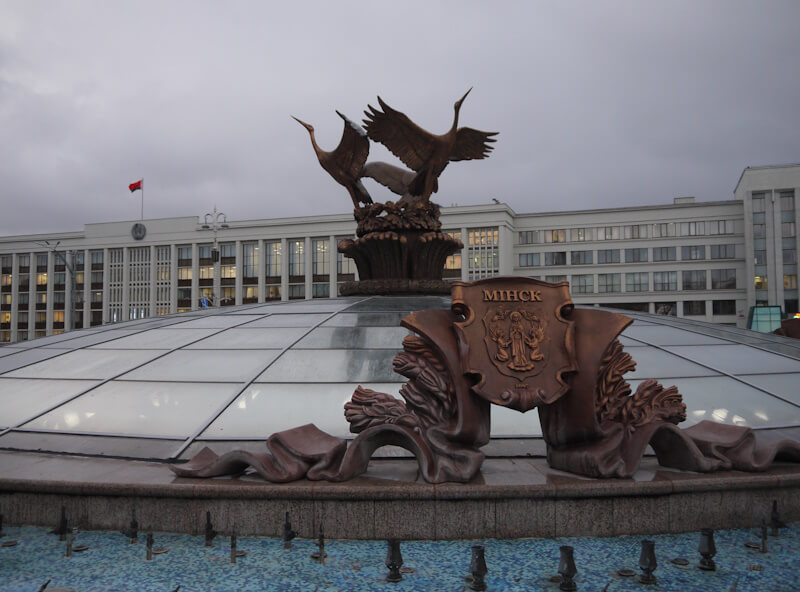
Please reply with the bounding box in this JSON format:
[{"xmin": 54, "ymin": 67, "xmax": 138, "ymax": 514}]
[{"xmin": 453, "ymin": 278, "xmax": 577, "ymax": 412}]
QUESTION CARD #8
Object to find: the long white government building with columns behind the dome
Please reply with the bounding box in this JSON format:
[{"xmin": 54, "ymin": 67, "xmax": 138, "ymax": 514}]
[{"xmin": 0, "ymin": 164, "xmax": 800, "ymax": 342}]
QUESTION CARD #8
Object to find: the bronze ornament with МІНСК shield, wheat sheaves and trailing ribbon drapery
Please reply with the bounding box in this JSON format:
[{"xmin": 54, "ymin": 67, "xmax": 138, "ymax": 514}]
[{"xmin": 171, "ymin": 277, "xmax": 800, "ymax": 483}]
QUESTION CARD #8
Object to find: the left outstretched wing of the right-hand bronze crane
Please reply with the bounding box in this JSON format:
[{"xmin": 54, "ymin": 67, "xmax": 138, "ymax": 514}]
[{"xmin": 364, "ymin": 97, "xmax": 435, "ymax": 171}]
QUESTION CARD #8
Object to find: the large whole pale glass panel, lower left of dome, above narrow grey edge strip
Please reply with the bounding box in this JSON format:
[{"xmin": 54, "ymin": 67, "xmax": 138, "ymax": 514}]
[{"xmin": 24, "ymin": 381, "xmax": 241, "ymax": 438}]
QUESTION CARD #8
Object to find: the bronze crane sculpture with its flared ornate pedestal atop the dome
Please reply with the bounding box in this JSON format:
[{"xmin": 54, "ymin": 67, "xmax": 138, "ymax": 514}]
[{"xmin": 294, "ymin": 89, "xmax": 497, "ymax": 295}]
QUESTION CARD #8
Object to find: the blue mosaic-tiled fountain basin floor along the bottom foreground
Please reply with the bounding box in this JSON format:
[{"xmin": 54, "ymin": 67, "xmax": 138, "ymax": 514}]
[{"xmin": 0, "ymin": 524, "xmax": 800, "ymax": 592}]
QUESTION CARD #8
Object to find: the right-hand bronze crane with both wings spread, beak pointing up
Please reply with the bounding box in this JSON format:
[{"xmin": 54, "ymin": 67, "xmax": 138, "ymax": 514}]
[{"xmin": 364, "ymin": 89, "xmax": 497, "ymax": 200}]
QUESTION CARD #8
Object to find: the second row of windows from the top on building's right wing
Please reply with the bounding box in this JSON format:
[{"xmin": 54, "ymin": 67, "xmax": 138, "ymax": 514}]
[{"xmin": 519, "ymin": 244, "xmax": 736, "ymax": 267}]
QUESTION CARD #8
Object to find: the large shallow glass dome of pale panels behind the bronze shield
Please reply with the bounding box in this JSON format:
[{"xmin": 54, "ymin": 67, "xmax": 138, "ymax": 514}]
[{"xmin": 0, "ymin": 296, "xmax": 800, "ymax": 459}]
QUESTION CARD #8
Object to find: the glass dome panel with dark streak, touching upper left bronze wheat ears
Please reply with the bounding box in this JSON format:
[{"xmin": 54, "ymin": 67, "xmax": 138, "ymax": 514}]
[{"xmin": 256, "ymin": 349, "xmax": 406, "ymax": 382}]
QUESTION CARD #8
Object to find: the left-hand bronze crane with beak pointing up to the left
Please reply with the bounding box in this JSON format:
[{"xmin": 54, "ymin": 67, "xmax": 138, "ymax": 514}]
[{"xmin": 292, "ymin": 111, "xmax": 372, "ymax": 208}]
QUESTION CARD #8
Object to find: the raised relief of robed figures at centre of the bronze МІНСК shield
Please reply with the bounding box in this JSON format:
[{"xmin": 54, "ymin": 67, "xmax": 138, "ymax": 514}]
[{"xmin": 488, "ymin": 308, "xmax": 544, "ymax": 372}]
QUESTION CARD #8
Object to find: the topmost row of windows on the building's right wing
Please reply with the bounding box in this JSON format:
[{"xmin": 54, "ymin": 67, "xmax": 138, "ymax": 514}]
[{"xmin": 519, "ymin": 220, "xmax": 735, "ymax": 245}]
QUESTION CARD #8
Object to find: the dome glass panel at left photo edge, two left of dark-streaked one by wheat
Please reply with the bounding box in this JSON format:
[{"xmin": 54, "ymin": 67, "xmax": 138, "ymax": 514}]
[{"xmin": 0, "ymin": 349, "xmax": 163, "ymax": 380}]
